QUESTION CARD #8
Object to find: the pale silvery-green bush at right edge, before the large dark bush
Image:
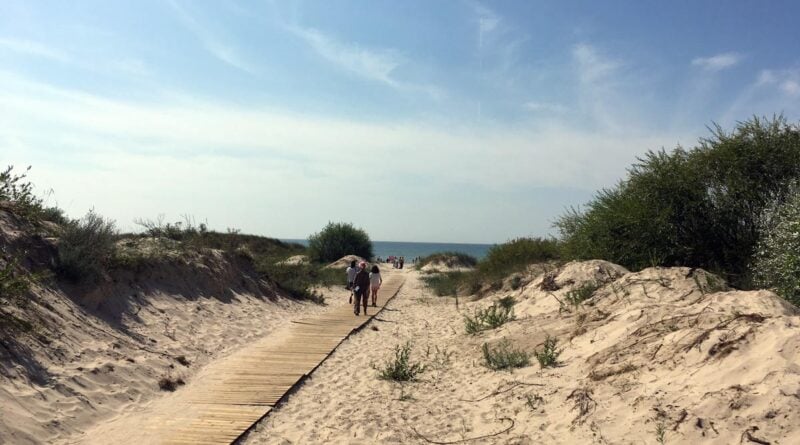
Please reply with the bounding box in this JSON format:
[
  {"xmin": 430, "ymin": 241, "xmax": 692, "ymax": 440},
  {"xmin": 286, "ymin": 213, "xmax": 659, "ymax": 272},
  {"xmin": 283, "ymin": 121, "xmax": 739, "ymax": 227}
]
[{"xmin": 752, "ymin": 184, "xmax": 800, "ymax": 305}]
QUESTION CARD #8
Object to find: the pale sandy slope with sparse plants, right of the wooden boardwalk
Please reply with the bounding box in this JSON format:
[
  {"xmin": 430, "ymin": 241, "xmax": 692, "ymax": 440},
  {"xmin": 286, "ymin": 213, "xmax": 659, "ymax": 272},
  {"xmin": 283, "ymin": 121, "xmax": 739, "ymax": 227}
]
[{"xmin": 245, "ymin": 261, "xmax": 800, "ymax": 444}]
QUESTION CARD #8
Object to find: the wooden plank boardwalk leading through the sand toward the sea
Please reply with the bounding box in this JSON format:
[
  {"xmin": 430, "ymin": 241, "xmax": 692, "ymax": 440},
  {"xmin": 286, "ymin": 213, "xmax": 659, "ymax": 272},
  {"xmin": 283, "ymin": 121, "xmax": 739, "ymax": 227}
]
[{"xmin": 159, "ymin": 274, "xmax": 405, "ymax": 445}]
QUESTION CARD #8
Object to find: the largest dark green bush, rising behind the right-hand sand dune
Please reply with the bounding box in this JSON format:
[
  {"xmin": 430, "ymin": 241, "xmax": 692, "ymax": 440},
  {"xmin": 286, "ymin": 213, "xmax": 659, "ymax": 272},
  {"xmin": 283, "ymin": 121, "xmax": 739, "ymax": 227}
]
[{"xmin": 555, "ymin": 116, "xmax": 800, "ymax": 286}]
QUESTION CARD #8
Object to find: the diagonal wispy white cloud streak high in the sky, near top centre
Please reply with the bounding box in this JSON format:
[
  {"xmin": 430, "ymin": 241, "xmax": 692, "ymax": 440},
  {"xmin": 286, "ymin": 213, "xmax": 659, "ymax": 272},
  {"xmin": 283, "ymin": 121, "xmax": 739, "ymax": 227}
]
[{"xmin": 288, "ymin": 26, "xmax": 442, "ymax": 98}]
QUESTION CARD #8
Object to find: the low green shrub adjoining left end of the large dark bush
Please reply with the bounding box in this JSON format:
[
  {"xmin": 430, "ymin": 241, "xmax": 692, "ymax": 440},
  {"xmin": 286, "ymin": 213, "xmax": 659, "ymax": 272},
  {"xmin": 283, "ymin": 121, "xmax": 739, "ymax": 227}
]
[{"xmin": 478, "ymin": 238, "xmax": 560, "ymax": 279}]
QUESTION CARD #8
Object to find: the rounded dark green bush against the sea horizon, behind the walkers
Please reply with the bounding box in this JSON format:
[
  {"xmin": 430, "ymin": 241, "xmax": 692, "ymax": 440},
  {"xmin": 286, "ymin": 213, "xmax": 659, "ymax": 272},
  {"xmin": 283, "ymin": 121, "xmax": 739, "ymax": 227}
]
[{"xmin": 308, "ymin": 223, "xmax": 372, "ymax": 262}]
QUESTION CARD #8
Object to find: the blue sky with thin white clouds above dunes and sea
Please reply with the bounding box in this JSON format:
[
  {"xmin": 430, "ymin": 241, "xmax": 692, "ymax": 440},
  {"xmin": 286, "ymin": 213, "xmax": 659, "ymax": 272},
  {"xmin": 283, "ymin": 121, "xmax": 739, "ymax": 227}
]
[{"xmin": 0, "ymin": 0, "xmax": 800, "ymax": 243}]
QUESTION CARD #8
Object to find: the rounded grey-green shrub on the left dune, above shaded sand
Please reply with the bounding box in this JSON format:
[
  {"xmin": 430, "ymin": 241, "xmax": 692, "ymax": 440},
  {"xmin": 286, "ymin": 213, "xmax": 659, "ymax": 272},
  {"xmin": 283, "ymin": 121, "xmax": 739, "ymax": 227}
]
[{"xmin": 58, "ymin": 210, "xmax": 116, "ymax": 281}]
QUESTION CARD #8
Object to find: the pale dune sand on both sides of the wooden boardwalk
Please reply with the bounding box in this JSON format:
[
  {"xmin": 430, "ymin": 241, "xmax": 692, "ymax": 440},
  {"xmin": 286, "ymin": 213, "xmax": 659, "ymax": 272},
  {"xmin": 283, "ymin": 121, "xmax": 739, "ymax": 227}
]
[{"xmin": 0, "ymin": 248, "xmax": 800, "ymax": 444}]
